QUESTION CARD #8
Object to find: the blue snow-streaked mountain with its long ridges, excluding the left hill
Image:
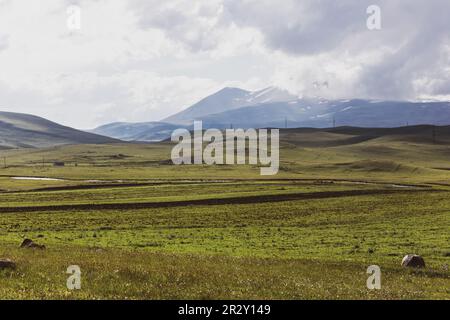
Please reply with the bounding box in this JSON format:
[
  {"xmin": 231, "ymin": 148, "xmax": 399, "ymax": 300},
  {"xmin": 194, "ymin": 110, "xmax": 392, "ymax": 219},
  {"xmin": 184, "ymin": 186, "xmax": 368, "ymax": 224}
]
[{"xmin": 92, "ymin": 87, "xmax": 450, "ymax": 141}]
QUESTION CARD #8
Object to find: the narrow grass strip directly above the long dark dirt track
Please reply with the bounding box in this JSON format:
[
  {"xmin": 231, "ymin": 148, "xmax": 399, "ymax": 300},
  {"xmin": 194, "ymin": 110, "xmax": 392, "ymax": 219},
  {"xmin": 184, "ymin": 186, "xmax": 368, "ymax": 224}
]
[{"xmin": 0, "ymin": 181, "xmax": 383, "ymax": 207}]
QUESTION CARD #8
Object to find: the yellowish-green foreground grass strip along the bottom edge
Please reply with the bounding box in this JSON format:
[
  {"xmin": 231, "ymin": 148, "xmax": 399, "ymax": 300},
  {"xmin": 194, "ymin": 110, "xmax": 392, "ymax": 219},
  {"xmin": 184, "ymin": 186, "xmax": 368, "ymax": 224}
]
[{"xmin": 0, "ymin": 247, "xmax": 449, "ymax": 299}]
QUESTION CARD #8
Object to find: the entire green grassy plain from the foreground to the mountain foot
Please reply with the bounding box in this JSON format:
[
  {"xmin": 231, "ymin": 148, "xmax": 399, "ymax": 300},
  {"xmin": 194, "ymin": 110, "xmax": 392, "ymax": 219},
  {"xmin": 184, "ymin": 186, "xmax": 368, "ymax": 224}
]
[{"xmin": 0, "ymin": 130, "xmax": 450, "ymax": 299}]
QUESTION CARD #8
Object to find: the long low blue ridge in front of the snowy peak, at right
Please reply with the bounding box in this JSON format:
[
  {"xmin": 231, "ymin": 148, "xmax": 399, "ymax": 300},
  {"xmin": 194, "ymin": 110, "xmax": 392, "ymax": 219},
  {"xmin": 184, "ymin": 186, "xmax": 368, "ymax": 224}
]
[{"xmin": 201, "ymin": 99, "xmax": 450, "ymax": 128}]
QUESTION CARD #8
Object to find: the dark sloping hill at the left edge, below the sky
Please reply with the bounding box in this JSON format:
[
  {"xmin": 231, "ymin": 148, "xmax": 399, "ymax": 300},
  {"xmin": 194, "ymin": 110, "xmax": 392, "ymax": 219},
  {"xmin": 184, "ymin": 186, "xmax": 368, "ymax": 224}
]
[{"xmin": 0, "ymin": 112, "xmax": 118, "ymax": 149}]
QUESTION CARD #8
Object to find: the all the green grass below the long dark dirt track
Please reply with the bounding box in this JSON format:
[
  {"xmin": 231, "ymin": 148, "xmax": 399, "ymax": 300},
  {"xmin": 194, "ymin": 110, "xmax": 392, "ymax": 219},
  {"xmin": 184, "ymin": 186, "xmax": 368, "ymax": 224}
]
[{"xmin": 0, "ymin": 187, "xmax": 450, "ymax": 299}]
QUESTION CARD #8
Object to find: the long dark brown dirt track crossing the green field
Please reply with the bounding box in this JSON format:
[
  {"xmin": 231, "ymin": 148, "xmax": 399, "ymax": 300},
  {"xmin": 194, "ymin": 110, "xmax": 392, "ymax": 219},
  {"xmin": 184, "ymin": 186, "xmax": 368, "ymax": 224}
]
[{"xmin": 0, "ymin": 189, "xmax": 440, "ymax": 213}]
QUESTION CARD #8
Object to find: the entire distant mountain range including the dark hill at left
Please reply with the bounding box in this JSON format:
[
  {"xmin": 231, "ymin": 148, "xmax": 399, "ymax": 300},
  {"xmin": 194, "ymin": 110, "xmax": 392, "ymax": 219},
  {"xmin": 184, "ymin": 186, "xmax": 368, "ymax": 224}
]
[{"xmin": 0, "ymin": 87, "xmax": 450, "ymax": 149}]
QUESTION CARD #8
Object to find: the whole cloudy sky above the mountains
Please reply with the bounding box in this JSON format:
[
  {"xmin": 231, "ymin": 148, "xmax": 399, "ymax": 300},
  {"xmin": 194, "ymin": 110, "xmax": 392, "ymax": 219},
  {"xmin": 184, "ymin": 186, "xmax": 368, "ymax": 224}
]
[{"xmin": 0, "ymin": 0, "xmax": 450, "ymax": 129}]
